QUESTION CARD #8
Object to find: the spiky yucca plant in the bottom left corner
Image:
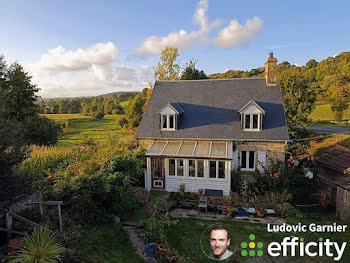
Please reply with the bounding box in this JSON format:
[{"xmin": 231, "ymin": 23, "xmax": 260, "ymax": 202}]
[{"xmin": 10, "ymin": 227, "xmax": 65, "ymax": 263}]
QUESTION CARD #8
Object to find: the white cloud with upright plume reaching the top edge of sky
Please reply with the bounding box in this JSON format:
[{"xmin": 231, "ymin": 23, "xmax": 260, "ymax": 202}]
[{"xmin": 137, "ymin": 0, "xmax": 220, "ymax": 55}]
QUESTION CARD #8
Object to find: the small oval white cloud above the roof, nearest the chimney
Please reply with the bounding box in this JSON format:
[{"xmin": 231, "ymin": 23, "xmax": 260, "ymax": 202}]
[{"xmin": 213, "ymin": 16, "xmax": 263, "ymax": 48}]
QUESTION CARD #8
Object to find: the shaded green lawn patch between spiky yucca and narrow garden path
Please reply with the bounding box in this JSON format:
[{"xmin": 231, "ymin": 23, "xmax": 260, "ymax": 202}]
[{"xmin": 67, "ymin": 223, "xmax": 144, "ymax": 263}]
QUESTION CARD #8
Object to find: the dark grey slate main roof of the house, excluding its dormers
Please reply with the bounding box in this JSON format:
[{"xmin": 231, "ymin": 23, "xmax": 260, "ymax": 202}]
[{"xmin": 136, "ymin": 78, "xmax": 289, "ymax": 141}]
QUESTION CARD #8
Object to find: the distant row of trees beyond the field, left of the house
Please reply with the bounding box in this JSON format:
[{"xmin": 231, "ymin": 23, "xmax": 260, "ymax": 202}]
[{"xmin": 38, "ymin": 92, "xmax": 138, "ymax": 115}]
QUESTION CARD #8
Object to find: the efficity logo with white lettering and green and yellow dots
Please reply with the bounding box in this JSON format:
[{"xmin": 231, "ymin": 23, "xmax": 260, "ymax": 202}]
[{"xmin": 241, "ymin": 234, "xmax": 347, "ymax": 261}]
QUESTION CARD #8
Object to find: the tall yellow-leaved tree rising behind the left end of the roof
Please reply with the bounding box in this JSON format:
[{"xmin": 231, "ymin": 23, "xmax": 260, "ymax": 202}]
[{"xmin": 154, "ymin": 47, "xmax": 180, "ymax": 80}]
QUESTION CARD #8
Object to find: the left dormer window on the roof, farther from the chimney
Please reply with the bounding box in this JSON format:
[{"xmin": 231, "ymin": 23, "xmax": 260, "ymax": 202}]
[{"xmin": 159, "ymin": 102, "xmax": 183, "ymax": 131}]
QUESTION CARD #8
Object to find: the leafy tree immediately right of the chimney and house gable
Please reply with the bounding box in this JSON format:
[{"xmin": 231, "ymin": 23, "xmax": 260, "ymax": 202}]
[{"xmin": 277, "ymin": 67, "xmax": 316, "ymax": 137}]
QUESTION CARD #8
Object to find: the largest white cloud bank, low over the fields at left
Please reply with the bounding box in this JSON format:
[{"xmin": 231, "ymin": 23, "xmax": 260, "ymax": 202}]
[{"xmin": 25, "ymin": 42, "xmax": 149, "ymax": 98}]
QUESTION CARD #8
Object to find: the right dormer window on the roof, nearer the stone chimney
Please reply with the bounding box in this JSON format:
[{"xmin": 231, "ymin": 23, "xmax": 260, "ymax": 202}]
[{"xmin": 239, "ymin": 100, "xmax": 265, "ymax": 131}]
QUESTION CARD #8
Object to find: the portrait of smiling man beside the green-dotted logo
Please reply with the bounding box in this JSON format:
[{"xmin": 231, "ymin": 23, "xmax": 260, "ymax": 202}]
[{"xmin": 210, "ymin": 225, "xmax": 233, "ymax": 260}]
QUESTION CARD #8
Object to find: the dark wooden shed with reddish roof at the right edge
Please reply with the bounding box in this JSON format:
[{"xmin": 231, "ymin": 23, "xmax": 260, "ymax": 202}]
[{"xmin": 315, "ymin": 145, "xmax": 350, "ymax": 222}]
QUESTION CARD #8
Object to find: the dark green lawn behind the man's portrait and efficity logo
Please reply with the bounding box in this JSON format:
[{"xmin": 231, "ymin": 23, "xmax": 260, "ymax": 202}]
[{"xmin": 167, "ymin": 218, "xmax": 350, "ymax": 263}]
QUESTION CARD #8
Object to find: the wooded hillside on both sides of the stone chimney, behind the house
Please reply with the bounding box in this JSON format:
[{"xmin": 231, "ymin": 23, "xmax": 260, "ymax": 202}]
[{"xmin": 208, "ymin": 52, "xmax": 350, "ymax": 121}]
